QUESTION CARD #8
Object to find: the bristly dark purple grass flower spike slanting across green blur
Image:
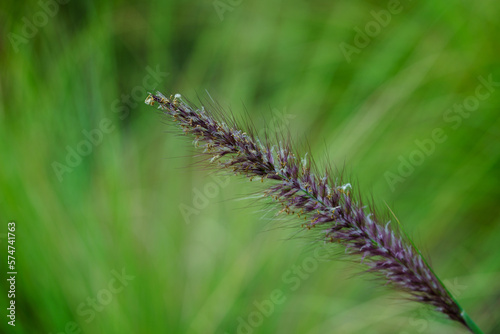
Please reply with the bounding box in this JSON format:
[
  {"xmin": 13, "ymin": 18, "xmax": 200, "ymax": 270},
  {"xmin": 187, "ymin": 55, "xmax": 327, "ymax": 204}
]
[{"xmin": 145, "ymin": 92, "xmax": 481, "ymax": 333}]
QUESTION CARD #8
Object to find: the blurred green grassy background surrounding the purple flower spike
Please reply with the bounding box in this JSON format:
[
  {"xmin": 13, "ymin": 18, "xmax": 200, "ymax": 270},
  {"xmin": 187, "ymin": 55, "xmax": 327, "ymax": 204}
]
[{"xmin": 0, "ymin": 0, "xmax": 500, "ymax": 334}]
